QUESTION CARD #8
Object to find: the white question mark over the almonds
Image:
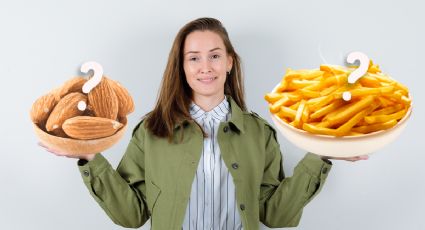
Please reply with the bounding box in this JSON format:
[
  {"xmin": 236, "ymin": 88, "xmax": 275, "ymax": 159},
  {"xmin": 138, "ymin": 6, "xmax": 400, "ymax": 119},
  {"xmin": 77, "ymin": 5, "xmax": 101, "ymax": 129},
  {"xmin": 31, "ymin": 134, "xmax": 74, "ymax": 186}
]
[{"xmin": 78, "ymin": 61, "xmax": 103, "ymax": 111}]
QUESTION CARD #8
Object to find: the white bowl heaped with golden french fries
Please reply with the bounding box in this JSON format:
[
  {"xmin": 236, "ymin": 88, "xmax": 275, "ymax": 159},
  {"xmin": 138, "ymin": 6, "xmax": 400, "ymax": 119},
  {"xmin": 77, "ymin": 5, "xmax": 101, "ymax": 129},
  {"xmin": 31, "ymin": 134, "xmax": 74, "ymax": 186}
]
[{"xmin": 265, "ymin": 62, "xmax": 412, "ymax": 157}]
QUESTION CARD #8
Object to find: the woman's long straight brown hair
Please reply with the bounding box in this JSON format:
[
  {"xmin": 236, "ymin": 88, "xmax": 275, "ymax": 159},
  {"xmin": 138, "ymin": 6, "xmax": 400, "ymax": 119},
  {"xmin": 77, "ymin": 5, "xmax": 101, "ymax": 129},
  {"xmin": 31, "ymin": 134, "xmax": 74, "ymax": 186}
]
[{"xmin": 145, "ymin": 18, "xmax": 246, "ymax": 141}]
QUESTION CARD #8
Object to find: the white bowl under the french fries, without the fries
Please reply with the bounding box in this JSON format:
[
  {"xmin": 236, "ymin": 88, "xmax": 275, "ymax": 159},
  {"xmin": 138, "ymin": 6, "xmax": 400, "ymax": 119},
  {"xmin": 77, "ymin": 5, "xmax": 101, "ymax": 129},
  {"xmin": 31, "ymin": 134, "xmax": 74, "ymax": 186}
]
[{"xmin": 271, "ymin": 86, "xmax": 413, "ymax": 157}]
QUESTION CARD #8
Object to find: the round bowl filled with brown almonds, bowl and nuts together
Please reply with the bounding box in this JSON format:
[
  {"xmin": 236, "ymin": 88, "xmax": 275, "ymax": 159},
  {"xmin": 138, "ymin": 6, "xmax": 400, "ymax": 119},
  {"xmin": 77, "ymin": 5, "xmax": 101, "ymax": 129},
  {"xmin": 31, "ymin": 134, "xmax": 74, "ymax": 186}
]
[{"xmin": 30, "ymin": 76, "xmax": 134, "ymax": 155}]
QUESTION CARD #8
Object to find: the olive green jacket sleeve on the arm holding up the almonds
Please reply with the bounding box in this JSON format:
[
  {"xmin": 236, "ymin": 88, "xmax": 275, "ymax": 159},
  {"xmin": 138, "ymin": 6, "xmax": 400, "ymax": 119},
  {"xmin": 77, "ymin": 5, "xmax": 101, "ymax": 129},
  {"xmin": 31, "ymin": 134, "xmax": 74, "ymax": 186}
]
[{"xmin": 78, "ymin": 121, "xmax": 149, "ymax": 228}]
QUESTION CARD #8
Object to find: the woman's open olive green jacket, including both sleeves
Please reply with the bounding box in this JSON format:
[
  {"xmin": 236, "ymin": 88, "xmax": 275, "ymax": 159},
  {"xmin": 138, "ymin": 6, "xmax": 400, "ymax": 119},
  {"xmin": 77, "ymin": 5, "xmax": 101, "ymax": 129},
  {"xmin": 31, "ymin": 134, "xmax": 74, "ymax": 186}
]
[{"xmin": 78, "ymin": 96, "xmax": 331, "ymax": 230}]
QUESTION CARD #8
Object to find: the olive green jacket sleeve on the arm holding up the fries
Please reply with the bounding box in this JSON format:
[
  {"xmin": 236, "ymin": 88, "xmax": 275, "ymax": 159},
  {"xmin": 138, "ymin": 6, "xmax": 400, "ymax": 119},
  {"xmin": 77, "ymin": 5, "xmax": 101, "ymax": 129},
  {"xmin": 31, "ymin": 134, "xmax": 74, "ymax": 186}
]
[{"xmin": 260, "ymin": 124, "xmax": 331, "ymax": 228}]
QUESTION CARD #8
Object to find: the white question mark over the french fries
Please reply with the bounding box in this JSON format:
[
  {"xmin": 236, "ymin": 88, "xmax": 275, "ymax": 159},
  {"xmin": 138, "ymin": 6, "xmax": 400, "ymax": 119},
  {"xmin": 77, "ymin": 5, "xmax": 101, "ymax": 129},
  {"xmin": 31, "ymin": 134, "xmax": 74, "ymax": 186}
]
[{"xmin": 342, "ymin": 51, "xmax": 369, "ymax": 101}]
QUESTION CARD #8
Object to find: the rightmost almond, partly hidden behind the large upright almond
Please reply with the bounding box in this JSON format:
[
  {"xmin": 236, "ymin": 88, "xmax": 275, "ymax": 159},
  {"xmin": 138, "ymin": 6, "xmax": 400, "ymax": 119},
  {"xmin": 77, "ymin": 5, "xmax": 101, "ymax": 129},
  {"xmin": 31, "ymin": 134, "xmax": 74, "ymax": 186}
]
[{"xmin": 107, "ymin": 78, "xmax": 134, "ymax": 117}]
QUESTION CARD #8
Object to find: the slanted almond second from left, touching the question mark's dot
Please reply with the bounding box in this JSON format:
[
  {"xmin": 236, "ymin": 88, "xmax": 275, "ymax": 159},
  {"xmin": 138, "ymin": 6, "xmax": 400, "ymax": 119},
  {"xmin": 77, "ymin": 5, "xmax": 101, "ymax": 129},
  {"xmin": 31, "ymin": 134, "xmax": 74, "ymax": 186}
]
[{"xmin": 46, "ymin": 92, "xmax": 87, "ymax": 132}]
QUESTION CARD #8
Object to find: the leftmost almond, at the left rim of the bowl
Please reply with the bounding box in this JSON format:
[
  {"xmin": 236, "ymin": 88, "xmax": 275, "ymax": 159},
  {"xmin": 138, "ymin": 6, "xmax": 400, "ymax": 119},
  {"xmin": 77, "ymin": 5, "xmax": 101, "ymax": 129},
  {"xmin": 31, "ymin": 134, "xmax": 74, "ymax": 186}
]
[{"xmin": 30, "ymin": 93, "xmax": 57, "ymax": 127}]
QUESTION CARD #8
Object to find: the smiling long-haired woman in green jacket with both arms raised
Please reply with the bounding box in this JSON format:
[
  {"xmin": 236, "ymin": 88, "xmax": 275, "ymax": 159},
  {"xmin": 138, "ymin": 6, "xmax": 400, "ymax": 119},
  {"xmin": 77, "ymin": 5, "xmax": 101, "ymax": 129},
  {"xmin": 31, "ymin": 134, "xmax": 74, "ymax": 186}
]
[{"xmin": 40, "ymin": 18, "xmax": 363, "ymax": 230}]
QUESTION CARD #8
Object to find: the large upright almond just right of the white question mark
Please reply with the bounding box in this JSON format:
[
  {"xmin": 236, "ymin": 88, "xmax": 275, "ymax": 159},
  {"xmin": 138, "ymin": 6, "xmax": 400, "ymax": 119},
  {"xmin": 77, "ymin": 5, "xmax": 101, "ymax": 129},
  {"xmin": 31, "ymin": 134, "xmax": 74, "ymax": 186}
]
[{"xmin": 88, "ymin": 78, "xmax": 118, "ymax": 120}]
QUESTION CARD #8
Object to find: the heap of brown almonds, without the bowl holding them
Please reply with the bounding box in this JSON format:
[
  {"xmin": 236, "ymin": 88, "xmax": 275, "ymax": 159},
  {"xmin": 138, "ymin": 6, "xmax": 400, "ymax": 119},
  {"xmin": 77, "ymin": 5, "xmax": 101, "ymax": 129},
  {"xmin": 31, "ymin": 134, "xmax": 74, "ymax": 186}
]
[{"xmin": 30, "ymin": 76, "xmax": 134, "ymax": 140}]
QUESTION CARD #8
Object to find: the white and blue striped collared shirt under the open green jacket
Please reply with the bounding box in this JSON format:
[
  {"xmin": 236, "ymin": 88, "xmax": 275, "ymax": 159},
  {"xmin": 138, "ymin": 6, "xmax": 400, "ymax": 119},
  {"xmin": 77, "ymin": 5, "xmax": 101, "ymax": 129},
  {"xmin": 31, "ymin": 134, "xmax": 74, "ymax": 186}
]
[{"xmin": 182, "ymin": 97, "xmax": 242, "ymax": 230}]
